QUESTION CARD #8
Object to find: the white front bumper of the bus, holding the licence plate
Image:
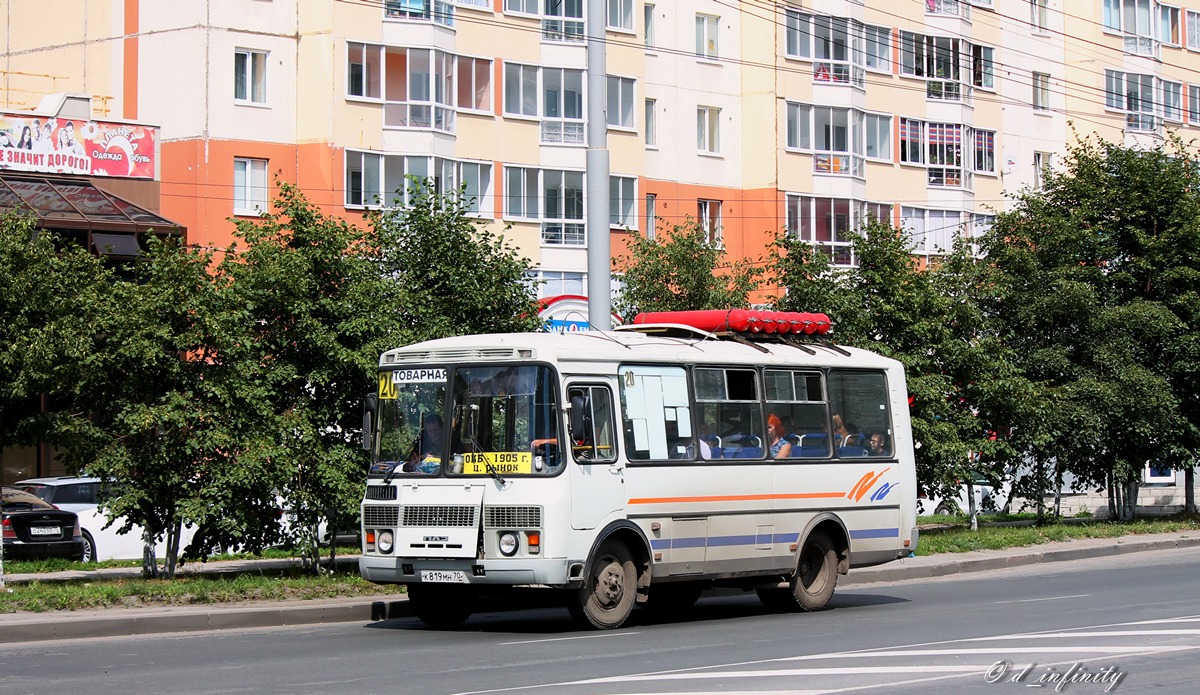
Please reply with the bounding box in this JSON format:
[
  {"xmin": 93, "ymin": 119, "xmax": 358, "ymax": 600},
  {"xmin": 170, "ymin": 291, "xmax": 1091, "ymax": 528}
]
[{"xmin": 359, "ymin": 555, "xmax": 578, "ymax": 587}]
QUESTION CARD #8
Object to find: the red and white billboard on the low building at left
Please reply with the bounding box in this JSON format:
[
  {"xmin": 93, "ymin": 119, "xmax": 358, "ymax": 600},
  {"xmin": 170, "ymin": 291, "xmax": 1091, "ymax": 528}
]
[{"xmin": 0, "ymin": 114, "xmax": 158, "ymax": 179}]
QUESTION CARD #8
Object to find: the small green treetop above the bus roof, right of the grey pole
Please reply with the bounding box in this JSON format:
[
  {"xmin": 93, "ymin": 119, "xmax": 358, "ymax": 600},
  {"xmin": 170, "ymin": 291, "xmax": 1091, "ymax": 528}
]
[{"xmin": 612, "ymin": 217, "xmax": 761, "ymax": 320}]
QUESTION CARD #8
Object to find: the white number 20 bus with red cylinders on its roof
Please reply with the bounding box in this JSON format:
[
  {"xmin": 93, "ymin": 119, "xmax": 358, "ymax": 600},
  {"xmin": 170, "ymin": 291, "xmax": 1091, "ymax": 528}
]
[{"xmin": 359, "ymin": 312, "xmax": 917, "ymax": 629}]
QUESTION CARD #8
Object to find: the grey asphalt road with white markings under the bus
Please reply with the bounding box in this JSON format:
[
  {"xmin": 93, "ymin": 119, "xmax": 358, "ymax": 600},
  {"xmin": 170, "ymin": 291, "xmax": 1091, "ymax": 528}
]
[{"xmin": 0, "ymin": 547, "xmax": 1200, "ymax": 695}]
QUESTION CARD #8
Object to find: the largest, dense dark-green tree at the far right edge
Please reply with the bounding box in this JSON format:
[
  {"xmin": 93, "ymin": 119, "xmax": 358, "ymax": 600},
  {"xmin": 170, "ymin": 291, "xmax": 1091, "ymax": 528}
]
[{"xmin": 980, "ymin": 133, "xmax": 1200, "ymax": 519}]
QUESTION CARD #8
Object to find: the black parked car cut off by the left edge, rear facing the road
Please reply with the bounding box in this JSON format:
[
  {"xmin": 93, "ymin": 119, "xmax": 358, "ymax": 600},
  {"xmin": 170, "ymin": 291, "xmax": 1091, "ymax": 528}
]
[{"xmin": 0, "ymin": 487, "xmax": 83, "ymax": 559}]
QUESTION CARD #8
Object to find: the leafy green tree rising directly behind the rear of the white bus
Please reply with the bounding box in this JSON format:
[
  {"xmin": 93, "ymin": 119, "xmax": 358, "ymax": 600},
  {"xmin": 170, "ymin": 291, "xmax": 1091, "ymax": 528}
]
[{"xmin": 770, "ymin": 221, "xmax": 1003, "ymax": 525}]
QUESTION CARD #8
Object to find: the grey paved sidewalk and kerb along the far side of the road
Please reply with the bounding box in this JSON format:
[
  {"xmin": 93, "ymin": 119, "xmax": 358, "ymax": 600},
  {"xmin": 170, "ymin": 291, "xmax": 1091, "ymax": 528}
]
[{"xmin": 0, "ymin": 532, "xmax": 1200, "ymax": 645}]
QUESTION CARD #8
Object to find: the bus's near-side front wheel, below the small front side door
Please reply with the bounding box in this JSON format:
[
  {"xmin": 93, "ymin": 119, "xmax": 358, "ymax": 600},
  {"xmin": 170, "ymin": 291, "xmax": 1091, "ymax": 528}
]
[{"xmin": 566, "ymin": 540, "xmax": 637, "ymax": 630}]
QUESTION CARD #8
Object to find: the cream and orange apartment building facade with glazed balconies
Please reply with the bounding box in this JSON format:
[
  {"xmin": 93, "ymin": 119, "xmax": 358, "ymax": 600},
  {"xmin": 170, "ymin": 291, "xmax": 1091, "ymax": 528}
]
[{"xmin": 0, "ymin": 0, "xmax": 1200, "ymax": 487}]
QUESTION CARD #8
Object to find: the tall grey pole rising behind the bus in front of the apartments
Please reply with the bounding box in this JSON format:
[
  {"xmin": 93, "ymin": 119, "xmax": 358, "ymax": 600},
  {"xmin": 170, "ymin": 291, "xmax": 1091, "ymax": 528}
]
[{"xmin": 583, "ymin": 0, "xmax": 612, "ymax": 330}]
